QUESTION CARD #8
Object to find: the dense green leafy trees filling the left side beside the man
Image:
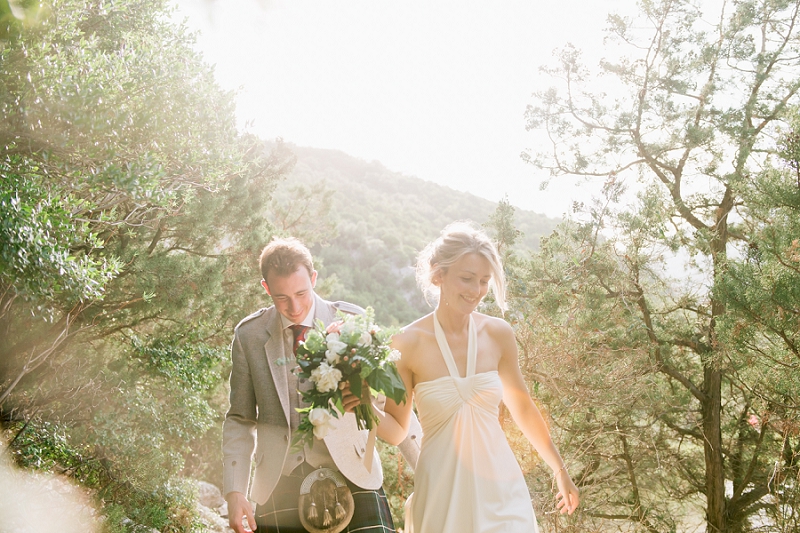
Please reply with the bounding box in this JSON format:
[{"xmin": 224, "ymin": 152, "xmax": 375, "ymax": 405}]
[{"xmin": 0, "ymin": 0, "xmax": 293, "ymax": 530}]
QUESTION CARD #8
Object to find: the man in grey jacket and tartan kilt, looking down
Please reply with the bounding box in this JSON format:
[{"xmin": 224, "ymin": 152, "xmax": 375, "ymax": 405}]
[{"xmin": 222, "ymin": 238, "xmax": 420, "ymax": 533}]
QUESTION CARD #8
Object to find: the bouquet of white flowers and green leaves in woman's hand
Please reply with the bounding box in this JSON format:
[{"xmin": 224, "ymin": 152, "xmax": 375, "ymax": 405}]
[{"xmin": 292, "ymin": 307, "xmax": 406, "ymax": 448}]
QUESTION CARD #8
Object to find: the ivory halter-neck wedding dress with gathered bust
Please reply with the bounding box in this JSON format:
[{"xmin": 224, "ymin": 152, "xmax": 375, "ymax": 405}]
[{"xmin": 406, "ymin": 313, "xmax": 538, "ymax": 533}]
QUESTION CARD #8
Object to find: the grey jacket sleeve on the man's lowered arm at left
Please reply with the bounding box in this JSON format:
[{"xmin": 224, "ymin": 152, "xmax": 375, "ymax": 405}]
[{"xmin": 222, "ymin": 328, "xmax": 257, "ymax": 495}]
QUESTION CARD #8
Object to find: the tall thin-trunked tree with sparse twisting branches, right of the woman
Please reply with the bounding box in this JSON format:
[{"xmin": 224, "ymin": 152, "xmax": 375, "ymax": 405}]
[{"xmin": 527, "ymin": 0, "xmax": 800, "ymax": 532}]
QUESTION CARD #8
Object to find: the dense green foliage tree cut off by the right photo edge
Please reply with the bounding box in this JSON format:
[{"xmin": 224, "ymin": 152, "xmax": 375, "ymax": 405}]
[{"xmin": 715, "ymin": 109, "xmax": 800, "ymax": 531}]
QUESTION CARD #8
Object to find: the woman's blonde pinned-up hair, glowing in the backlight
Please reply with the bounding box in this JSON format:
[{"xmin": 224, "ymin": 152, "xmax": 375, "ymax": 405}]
[{"xmin": 416, "ymin": 221, "xmax": 508, "ymax": 313}]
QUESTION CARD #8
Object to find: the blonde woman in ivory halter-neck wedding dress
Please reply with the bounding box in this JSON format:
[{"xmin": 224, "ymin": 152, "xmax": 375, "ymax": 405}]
[{"xmin": 380, "ymin": 222, "xmax": 579, "ymax": 533}]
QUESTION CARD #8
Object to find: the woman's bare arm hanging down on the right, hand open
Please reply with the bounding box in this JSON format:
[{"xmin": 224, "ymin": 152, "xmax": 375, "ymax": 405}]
[{"xmin": 492, "ymin": 320, "xmax": 580, "ymax": 514}]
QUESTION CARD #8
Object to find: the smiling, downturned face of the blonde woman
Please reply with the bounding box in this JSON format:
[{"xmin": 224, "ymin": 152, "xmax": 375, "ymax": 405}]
[{"xmin": 434, "ymin": 252, "xmax": 492, "ymax": 313}]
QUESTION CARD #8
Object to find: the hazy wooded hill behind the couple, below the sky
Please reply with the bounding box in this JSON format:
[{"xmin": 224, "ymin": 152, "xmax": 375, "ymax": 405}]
[{"xmin": 268, "ymin": 142, "xmax": 559, "ymax": 325}]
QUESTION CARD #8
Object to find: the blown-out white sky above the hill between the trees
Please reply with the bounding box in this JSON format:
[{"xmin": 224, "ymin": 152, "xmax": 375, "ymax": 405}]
[{"xmin": 176, "ymin": 0, "xmax": 635, "ymax": 216}]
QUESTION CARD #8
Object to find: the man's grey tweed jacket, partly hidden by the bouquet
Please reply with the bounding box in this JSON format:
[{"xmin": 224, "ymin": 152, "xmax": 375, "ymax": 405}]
[{"xmin": 222, "ymin": 294, "xmax": 421, "ymax": 504}]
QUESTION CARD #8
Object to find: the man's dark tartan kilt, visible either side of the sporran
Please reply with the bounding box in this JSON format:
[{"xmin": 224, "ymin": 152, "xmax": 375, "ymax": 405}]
[{"xmin": 255, "ymin": 463, "xmax": 395, "ymax": 533}]
